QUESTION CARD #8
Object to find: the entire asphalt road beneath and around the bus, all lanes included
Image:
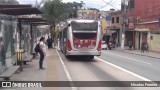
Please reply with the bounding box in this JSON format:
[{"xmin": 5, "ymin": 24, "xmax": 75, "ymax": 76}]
[{"xmin": 56, "ymin": 50, "xmax": 160, "ymax": 90}]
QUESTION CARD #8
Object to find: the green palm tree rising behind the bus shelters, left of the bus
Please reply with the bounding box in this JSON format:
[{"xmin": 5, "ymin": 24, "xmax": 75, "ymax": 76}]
[{"xmin": 42, "ymin": 0, "xmax": 66, "ymax": 38}]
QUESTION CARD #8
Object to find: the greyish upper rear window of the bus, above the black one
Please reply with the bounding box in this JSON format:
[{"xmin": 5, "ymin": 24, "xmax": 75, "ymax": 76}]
[{"xmin": 71, "ymin": 21, "xmax": 98, "ymax": 31}]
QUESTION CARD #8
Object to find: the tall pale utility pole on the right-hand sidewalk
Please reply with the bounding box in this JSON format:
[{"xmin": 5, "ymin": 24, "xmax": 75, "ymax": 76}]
[{"xmin": 121, "ymin": 0, "xmax": 128, "ymax": 50}]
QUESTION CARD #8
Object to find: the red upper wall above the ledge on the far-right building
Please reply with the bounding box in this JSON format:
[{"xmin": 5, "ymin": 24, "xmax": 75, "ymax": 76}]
[{"xmin": 135, "ymin": 0, "xmax": 160, "ymax": 22}]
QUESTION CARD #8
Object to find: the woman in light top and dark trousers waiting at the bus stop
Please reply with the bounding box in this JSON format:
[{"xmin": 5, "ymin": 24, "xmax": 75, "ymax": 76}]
[{"xmin": 39, "ymin": 37, "xmax": 46, "ymax": 69}]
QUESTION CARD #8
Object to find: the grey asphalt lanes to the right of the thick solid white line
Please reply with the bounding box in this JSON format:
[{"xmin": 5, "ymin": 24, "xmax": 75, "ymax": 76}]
[{"xmin": 100, "ymin": 51, "xmax": 160, "ymax": 81}]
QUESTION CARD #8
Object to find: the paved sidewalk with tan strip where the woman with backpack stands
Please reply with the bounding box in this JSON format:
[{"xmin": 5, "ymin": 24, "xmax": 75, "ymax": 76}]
[{"xmin": 0, "ymin": 49, "xmax": 59, "ymax": 90}]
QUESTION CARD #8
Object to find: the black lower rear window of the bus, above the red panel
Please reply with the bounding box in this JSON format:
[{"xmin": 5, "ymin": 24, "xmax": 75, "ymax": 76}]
[{"xmin": 73, "ymin": 33, "xmax": 96, "ymax": 39}]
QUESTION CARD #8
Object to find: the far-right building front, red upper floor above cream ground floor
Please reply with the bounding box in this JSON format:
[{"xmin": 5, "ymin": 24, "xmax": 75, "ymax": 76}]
[{"xmin": 134, "ymin": 0, "xmax": 160, "ymax": 52}]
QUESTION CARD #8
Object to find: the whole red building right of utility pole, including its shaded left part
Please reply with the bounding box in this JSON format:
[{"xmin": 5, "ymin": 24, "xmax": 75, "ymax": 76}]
[{"xmin": 121, "ymin": 0, "xmax": 160, "ymax": 52}]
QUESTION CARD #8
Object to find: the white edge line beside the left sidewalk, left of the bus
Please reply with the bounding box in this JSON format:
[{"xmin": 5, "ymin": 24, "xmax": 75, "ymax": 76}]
[{"xmin": 56, "ymin": 50, "xmax": 77, "ymax": 90}]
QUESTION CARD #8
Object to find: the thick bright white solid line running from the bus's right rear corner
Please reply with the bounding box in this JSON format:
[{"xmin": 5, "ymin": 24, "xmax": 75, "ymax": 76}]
[{"xmin": 95, "ymin": 57, "xmax": 151, "ymax": 81}]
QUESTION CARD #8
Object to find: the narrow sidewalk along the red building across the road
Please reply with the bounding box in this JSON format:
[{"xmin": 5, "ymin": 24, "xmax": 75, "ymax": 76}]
[{"xmin": 113, "ymin": 47, "xmax": 160, "ymax": 59}]
